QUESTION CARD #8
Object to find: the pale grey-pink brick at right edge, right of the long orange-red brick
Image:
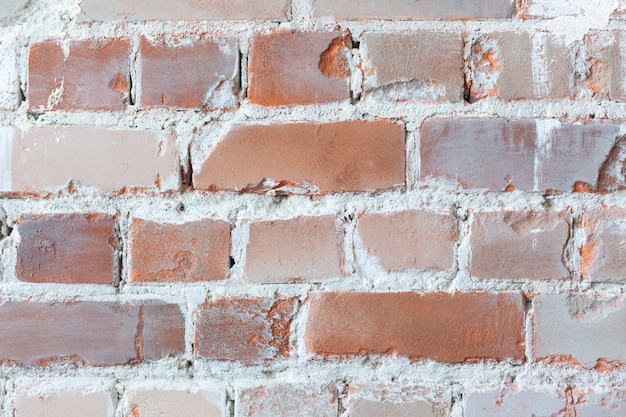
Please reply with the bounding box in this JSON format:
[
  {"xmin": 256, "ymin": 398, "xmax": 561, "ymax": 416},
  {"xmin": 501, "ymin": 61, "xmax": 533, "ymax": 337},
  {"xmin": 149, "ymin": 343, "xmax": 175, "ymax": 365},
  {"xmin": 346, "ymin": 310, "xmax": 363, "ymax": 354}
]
[{"xmin": 533, "ymin": 294, "xmax": 626, "ymax": 368}]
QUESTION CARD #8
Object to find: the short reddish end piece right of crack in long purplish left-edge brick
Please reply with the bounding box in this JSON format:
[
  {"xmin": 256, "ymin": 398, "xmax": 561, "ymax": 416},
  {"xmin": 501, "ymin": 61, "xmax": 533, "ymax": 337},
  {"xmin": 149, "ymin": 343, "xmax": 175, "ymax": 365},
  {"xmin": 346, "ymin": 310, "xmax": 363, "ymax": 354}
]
[{"xmin": 139, "ymin": 303, "xmax": 185, "ymax": 359}]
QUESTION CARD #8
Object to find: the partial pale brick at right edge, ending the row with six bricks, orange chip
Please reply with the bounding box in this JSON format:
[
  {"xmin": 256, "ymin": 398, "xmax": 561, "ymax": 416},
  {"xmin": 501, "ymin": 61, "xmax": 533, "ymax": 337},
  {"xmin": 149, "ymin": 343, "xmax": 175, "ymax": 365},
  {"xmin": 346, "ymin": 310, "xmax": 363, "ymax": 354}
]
[{"xmin": 580, "ymin": 209, "xmax": 626, "ymax": 282}]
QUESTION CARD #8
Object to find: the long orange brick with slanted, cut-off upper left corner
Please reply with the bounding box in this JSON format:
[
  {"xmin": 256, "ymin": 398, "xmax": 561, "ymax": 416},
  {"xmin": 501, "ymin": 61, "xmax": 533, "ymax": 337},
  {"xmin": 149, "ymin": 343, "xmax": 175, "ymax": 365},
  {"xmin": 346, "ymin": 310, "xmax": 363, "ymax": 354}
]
[{"xmin": 194, "ymin": 121, "xmax": 405, "ymax": 193}]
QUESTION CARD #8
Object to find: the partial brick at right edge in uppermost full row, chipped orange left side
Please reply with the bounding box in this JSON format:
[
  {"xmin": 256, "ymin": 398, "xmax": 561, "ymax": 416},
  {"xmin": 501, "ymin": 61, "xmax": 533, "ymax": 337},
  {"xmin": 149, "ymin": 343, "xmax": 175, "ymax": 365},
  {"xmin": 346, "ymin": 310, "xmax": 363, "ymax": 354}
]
[{"xmin": 583, "ymin": 31, "xmax": 626, "ymax": 100}]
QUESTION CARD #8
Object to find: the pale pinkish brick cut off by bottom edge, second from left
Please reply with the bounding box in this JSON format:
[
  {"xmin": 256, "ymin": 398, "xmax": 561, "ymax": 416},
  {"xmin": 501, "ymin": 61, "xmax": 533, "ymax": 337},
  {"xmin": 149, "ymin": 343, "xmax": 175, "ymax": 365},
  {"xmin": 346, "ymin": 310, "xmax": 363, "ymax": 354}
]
[{"xmin": 126, "ymin": 389, "xmax": 226, "ymax": 417}]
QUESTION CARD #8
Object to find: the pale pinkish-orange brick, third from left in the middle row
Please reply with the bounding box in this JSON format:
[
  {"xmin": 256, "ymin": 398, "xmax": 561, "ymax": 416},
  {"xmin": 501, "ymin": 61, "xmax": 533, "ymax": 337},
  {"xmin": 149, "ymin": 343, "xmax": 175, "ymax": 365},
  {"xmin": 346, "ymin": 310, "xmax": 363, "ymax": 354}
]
[{"xmin": 245, "ymin": 216, "xmax": 342, "ymax": 282}]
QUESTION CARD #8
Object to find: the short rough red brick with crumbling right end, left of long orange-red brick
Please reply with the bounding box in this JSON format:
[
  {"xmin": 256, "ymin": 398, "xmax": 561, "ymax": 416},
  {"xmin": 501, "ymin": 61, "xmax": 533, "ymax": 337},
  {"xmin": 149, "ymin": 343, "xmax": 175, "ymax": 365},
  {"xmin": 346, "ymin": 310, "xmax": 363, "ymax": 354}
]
[{"xmin": 195, "ymin": 298, "xmax": 296, "ymax": 365}]
